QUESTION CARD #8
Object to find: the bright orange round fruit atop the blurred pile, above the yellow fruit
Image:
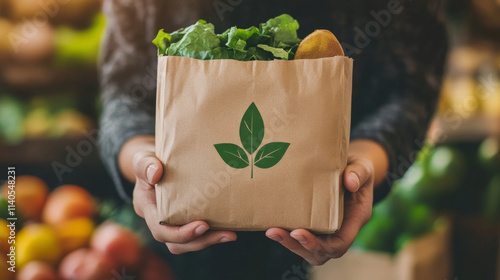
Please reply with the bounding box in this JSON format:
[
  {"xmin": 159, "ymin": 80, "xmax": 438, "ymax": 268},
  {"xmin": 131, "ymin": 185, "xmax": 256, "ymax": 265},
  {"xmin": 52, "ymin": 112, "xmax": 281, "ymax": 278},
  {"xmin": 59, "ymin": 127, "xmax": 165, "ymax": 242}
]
[{"xmin": 42, "ymin": 185, "xmax": 96, "ymax": 225}]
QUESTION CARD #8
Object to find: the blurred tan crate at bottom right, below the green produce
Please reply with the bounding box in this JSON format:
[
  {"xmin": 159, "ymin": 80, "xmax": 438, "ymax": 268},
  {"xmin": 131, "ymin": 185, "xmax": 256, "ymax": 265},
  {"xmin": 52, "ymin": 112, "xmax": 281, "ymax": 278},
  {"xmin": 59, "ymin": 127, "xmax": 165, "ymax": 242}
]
[{"xmin": 311, "ymin": 221, "xmax": 452, "ymax": 280}]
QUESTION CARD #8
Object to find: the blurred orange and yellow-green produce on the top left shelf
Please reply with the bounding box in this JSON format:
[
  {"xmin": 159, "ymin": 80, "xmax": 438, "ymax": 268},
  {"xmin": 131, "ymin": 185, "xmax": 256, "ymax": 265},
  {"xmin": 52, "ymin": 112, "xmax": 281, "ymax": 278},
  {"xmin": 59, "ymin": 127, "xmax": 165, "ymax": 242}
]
[{"xmin": 0, "ymin": 0, "xmax": 105, "ymax": 67}]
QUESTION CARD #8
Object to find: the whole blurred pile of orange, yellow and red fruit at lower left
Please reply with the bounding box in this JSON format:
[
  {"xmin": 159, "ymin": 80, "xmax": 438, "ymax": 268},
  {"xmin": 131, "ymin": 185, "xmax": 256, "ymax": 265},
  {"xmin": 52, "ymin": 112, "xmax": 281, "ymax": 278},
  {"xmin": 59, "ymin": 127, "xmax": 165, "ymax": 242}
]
[{"xmin": 0, "ymin": 175, "xmax": 173, "ymax": 280}]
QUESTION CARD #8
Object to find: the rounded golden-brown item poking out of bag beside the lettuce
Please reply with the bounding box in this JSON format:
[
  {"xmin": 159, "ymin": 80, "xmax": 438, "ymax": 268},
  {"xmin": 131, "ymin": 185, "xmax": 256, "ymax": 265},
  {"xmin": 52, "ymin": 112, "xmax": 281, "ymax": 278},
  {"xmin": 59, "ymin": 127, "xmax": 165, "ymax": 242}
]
[{"xmin": 295, "ymin": 29, "xmax": 344, "ymax": 59}]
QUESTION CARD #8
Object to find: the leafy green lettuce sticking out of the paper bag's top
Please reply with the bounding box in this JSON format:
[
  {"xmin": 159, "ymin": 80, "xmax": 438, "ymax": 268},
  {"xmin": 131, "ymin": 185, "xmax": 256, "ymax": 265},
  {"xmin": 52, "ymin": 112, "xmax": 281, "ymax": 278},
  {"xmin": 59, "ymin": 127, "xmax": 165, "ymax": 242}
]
[{"xmin": 153, "ymin": 14, "xmax": 301, "ymax": 61}]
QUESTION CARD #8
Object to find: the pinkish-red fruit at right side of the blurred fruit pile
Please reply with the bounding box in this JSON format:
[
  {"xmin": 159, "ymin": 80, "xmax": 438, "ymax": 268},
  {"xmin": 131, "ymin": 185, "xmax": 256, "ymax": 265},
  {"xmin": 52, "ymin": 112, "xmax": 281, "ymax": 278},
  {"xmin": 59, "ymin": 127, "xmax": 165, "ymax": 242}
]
[{"xmin": 90, "ymin": 222, "xmax": 142, "ymax": 269}]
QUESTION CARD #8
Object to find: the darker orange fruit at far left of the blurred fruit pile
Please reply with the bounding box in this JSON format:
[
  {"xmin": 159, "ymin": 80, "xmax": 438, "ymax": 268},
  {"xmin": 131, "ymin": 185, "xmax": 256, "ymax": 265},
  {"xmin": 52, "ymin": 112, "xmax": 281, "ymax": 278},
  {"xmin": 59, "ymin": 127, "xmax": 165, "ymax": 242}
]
[{"xmin": 2, "ymin": 175, "xmax": 49, "ymax": 220}]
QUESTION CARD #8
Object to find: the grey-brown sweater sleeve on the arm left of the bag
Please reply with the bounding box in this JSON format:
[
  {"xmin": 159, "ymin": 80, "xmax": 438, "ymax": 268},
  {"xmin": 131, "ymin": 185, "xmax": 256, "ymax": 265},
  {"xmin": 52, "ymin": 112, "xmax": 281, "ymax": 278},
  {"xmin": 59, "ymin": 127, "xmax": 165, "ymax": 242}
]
[{"xmin": 99, "ymin": 0, "xmax": 160, "ymax": 202}]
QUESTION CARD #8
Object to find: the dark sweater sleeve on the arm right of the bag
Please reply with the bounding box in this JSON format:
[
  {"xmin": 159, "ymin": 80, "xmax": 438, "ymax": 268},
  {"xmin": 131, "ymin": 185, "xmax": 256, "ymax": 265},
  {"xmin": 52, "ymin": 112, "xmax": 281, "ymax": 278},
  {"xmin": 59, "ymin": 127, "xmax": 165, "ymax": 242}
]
[{"xmin": 351, "ymin": 1, "xmax": 447, "ymax": 202}]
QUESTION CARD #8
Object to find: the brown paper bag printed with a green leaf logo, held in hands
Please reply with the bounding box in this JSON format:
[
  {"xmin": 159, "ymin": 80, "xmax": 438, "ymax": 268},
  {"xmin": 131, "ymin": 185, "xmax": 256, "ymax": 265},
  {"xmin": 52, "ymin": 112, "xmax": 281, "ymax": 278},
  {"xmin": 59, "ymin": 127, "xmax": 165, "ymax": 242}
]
[{"xmin": 156, "ymin": 56, "xmax": 353, "ymax": 233}]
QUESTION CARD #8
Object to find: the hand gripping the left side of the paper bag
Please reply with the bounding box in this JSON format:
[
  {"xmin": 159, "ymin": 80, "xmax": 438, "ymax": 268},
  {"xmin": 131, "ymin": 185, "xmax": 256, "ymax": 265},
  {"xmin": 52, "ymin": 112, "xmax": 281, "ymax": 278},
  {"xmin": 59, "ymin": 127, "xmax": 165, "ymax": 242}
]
[{"xmin": 120, "ymin": 138, "xmax": 236, "ymax": 254}]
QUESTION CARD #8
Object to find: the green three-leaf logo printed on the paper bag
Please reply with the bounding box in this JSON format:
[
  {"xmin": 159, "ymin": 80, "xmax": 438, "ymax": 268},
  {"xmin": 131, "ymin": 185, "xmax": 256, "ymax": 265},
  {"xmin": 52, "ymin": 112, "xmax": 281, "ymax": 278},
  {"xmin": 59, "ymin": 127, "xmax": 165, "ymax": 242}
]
[{"xmin": 214, "ymin": 102, "xmax": 290, "ymax": 178}]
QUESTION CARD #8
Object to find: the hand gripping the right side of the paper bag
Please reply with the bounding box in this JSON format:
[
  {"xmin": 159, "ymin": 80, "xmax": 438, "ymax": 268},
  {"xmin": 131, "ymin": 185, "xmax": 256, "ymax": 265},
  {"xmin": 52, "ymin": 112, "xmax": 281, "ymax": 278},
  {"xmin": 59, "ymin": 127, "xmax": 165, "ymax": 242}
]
[{"xmin": 266, "ymin": 140, "xmax": 388, "ymax": 265}]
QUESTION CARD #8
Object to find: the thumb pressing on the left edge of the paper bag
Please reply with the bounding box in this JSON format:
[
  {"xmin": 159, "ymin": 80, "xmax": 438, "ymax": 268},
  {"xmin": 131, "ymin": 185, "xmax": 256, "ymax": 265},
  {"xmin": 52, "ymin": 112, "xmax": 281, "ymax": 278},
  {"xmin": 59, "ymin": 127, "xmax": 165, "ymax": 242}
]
[{"xmin": 134, "ymin": 152, "xmax": 163, "ymax": 185}]
